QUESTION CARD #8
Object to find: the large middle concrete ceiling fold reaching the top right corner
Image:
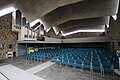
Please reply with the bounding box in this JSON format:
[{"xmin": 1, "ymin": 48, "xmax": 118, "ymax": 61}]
[{"xmin": 41, "ymin": 0, "xmax": 119, "ymax": 28}]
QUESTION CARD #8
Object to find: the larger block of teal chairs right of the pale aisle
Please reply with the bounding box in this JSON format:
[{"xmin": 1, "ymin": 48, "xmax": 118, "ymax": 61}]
[{"xmin": 51, "ymin": 48, "xmax": 118, "ymax": 75}]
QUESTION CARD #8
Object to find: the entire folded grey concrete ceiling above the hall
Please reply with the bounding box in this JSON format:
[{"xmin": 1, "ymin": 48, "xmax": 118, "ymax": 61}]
[{"xmin": 0, "ymin": 0, "xmax": 119, "ymax": 35}]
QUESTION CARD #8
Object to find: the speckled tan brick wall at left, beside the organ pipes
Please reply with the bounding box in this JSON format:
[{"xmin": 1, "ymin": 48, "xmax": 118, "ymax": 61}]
[{"xmin": 0, "ymin": 14, "xmax": 17, "ymax": 58}]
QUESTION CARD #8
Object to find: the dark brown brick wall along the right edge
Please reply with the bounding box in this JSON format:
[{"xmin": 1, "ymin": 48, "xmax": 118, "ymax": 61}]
[{"xmin": 108, "ymin": 6, "xmax": 120, "ymax": 50}]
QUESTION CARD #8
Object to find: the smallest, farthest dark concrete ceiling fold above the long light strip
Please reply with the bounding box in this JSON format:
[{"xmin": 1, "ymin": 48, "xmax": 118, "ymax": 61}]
[{"xmin": 55, "ymin": 16, "xmax": 110, "ymax": 32}]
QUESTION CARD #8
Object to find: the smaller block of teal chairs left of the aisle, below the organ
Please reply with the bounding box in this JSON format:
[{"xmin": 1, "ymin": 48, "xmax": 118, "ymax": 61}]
[{"xmin": 23, "ymin": 49, "xmax": 64, "ymax": 61}]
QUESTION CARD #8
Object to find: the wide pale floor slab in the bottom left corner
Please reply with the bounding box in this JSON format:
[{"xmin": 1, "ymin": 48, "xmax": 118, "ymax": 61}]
[{"xmin": 0, "ymin": 64, "xmax": 45, "ymax": 80}]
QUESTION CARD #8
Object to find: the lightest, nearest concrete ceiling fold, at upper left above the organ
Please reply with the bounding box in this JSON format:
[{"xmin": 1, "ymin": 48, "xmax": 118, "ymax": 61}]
[{"xmin": 16, "ymin": 0, "xmax": 83, "ymax": 22}]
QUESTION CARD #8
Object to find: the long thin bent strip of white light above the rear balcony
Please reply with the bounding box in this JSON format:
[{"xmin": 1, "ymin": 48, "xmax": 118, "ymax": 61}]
[{"xmin": 61, "ymin": 29, "xmax": 105, "ymax": 36}]
